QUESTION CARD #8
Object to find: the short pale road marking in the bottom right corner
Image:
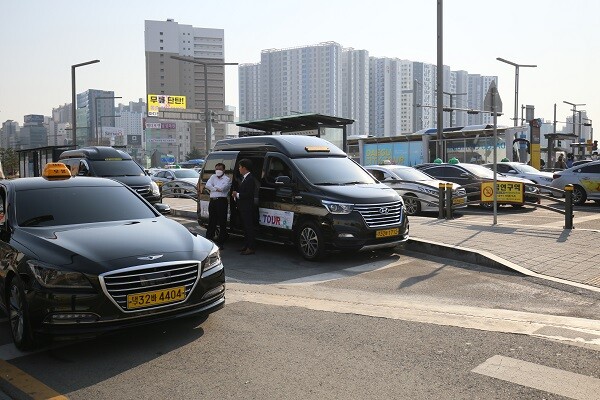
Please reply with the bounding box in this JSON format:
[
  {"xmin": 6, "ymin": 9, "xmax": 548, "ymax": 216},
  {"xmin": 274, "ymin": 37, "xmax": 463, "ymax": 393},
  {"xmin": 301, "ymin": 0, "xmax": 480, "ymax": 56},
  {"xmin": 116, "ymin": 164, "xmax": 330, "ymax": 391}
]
[{"xmin": 472, "ymin": 355, "xmax": 600, "ymax": 400}]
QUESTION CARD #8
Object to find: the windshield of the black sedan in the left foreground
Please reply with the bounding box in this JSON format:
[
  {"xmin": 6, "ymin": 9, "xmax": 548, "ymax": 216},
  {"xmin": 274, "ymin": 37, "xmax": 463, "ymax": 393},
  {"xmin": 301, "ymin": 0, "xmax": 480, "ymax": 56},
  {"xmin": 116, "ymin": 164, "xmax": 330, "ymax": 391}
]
[{"xmin": 15, "ymin": 186, "xmax": 157, "ymax": 227}]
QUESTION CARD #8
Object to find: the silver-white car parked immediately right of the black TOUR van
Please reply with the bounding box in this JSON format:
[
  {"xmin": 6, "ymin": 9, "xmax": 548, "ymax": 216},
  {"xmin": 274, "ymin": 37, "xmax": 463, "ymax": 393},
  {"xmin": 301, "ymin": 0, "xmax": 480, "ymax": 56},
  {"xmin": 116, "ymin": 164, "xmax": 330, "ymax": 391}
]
[{"xmin": 365, "ymin": 165, "xmax": 467, "ymax": 215}]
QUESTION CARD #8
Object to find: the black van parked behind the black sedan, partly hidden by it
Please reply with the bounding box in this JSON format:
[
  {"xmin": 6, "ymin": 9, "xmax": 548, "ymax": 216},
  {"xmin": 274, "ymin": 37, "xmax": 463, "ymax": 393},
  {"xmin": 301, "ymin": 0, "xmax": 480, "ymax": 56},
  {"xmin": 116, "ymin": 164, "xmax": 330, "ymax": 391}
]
[{"xmin": 59, "ymin": 146, "xmax": 161, "ymax": 204}]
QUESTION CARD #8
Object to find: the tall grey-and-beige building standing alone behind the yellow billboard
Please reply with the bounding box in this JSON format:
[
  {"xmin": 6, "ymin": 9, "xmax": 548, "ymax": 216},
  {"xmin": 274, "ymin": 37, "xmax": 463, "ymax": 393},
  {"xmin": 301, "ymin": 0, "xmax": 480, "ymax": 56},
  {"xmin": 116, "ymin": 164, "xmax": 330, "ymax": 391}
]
[{"xmin": 144, "ymin": 19, "xmax": 225, "ymax": 155}]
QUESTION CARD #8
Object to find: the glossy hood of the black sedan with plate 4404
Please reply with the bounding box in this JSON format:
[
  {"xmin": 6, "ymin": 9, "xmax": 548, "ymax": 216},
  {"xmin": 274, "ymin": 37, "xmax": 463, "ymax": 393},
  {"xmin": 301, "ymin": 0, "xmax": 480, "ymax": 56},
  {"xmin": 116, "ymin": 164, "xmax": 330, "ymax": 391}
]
[{"xmin": 14, "ymin": 217, "xmax": 213, "ymax": 274}]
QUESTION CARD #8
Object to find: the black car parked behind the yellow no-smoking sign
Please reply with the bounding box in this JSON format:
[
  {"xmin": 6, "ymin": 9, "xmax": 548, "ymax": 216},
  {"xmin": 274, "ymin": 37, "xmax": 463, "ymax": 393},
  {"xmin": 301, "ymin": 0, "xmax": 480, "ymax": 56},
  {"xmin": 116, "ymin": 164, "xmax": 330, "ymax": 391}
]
[{"xmin": 415, "ymin": 163, "xmax": 540, "ymax": 208}]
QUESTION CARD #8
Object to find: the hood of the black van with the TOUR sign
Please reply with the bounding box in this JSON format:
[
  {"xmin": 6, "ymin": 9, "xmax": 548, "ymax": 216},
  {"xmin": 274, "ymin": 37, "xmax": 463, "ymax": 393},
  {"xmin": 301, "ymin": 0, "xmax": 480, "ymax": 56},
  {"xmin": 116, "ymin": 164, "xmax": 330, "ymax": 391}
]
[{"xmin": 317, "ymin": 183, "xmax": 400, "ymax": 204}]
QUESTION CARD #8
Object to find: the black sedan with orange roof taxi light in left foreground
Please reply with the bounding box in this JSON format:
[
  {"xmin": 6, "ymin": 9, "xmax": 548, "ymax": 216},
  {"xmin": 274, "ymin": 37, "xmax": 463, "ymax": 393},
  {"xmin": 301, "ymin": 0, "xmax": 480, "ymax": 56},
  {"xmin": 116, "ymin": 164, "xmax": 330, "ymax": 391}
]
[{"xmin": 0, "ymin": 164, "xmax": 225, "ymax": 350}]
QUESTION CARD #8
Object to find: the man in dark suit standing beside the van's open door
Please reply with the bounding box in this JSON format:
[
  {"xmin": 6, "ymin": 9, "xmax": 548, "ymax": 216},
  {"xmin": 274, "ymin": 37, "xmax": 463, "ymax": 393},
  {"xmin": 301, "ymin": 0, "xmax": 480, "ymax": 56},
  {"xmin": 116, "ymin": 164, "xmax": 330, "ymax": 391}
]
[{"xmin": 231, "ymin": 158, "xmax": 256, "ymax": 256}]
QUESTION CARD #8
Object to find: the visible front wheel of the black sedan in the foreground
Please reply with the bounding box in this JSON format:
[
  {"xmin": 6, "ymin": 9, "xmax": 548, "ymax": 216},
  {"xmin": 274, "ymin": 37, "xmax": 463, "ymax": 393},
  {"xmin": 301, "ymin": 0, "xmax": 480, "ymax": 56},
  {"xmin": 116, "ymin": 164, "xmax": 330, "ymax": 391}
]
[{"xmin": 8, "ymin": 275, "xmax": 36, "ymax": 351}]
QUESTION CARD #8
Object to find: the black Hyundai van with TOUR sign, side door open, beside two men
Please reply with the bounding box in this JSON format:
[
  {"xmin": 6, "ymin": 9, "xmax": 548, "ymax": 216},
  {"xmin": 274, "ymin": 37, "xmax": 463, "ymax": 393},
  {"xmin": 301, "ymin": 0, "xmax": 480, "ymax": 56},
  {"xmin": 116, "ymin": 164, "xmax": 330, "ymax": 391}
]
[{"xmin": 198, "ymin": 135, "xmax": 409, "ymax": 260}]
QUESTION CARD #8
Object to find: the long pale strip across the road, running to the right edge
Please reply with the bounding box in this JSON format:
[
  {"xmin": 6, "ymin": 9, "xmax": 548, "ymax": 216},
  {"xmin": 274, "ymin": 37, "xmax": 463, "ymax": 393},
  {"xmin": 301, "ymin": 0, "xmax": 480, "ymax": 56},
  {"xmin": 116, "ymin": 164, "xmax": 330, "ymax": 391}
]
[{"xmin": 226, "ymin": 283, "xmax": 600, "ymax": 351}]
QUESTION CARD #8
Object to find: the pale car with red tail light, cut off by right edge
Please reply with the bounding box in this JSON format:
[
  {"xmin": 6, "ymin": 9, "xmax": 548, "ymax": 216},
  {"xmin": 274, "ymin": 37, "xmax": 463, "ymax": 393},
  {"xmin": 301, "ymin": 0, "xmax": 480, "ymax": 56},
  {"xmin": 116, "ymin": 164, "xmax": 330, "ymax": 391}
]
[{"xmin": 551, "ymin": 160, "xmax": 600, "ymax": 205}]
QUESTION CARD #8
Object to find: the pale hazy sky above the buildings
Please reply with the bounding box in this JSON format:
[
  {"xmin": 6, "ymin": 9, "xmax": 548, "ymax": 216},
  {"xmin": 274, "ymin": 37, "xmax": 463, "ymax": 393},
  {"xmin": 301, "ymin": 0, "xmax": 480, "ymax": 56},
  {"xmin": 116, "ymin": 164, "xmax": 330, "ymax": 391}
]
[{"xmin": 0, "ymin": 0, "xmax": 600, "ymax": 130}]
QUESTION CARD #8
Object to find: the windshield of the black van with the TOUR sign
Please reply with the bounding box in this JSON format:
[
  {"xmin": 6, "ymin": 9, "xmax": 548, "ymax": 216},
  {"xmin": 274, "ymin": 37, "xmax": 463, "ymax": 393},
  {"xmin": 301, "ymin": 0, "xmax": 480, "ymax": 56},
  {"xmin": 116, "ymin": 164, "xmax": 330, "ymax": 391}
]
[{"xmin": 293, "ymin": 157, "xmax": 377, "ymax": 185}]
